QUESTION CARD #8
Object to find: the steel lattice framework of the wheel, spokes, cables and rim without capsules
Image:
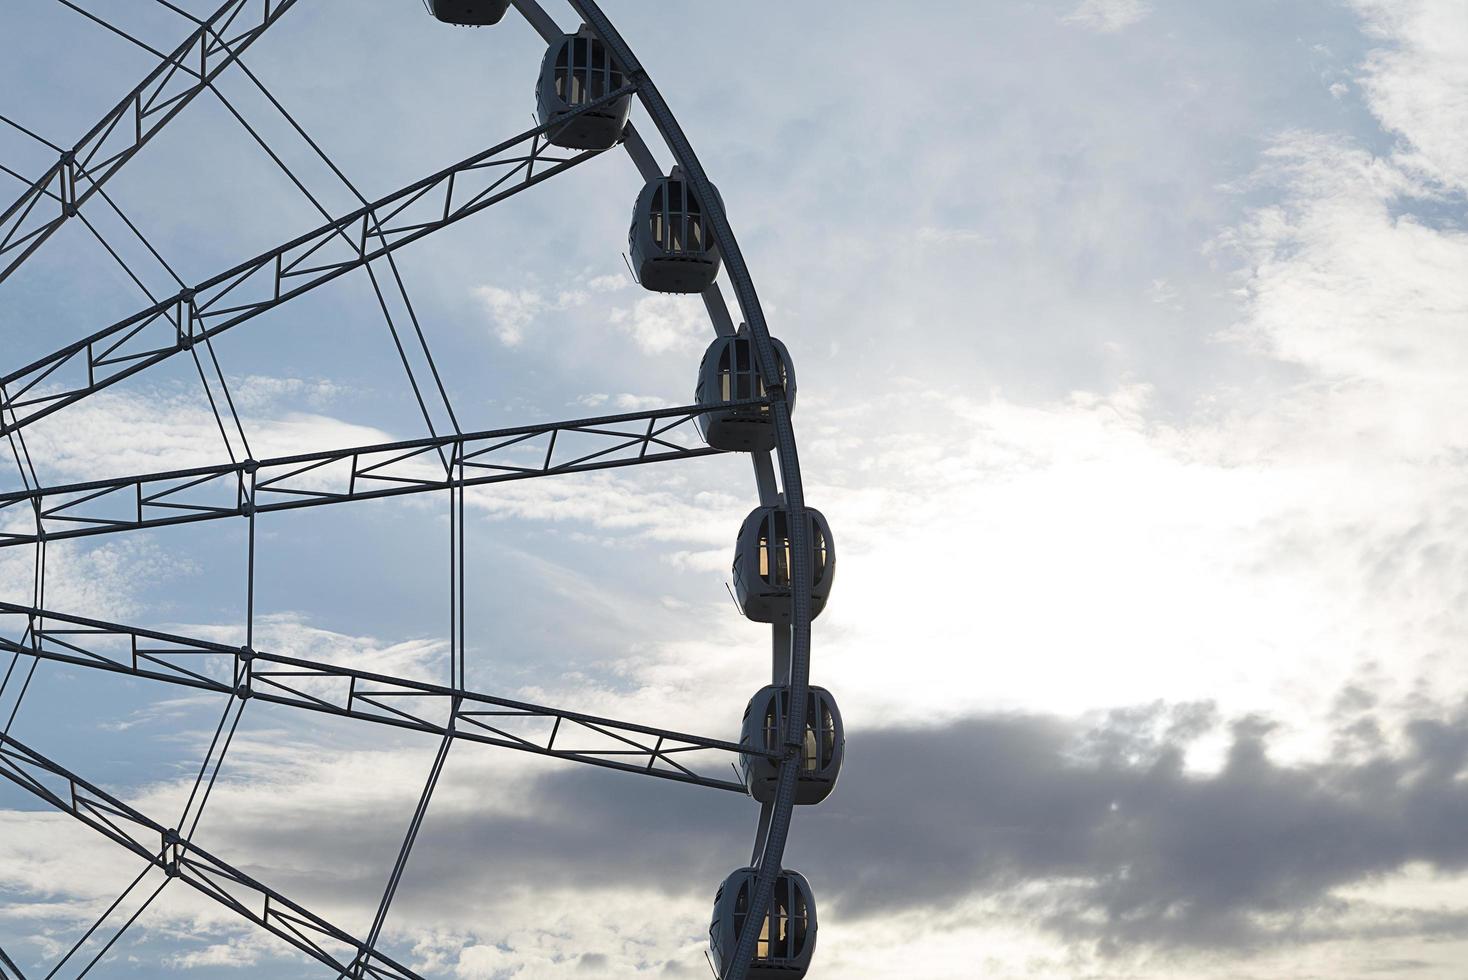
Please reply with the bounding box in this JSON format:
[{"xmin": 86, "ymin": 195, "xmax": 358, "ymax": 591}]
[{"xmin": 0, "ymin": 0, "xmax": 810, "ymax": 980}]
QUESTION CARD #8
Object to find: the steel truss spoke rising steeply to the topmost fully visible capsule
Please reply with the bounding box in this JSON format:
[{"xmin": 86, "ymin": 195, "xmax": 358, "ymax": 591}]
[{"xmin": 0, "ymin": 85, "xmax": 636, "ymax": 436}]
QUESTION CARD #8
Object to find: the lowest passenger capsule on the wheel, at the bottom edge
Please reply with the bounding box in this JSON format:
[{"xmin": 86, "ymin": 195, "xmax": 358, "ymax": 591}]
[{"xmin": 709, "ymin": 867, "xmax": 816, "ymax": 980}]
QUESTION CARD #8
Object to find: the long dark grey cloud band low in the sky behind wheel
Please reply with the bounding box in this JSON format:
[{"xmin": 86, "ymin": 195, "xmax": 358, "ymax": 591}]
[{"xmin": 212, "ymin": 691, "xmax": 1468, "ymax": 952}]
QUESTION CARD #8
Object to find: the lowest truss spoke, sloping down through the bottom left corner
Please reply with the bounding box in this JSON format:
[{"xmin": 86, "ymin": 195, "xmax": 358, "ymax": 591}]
[{"xmin": 0, "ymin": 735, "xmax": 421, "ymax": 980}]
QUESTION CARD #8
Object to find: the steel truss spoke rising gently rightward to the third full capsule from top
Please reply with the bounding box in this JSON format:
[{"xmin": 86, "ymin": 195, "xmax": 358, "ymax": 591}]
[{"xmin": 0, "ymin": 399, "xmax": 745, "ymax": 547}]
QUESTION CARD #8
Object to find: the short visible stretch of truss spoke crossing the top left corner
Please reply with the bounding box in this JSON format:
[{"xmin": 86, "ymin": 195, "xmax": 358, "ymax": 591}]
[{"xmin": 0, "ymin": 0, "xmax": 295, "ymax": 282}]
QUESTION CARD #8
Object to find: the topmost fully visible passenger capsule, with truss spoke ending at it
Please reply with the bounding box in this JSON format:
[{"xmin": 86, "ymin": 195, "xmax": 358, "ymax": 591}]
[{"xmin": 536, "ymin": 25, "xmax": 633, "ymax": 150}]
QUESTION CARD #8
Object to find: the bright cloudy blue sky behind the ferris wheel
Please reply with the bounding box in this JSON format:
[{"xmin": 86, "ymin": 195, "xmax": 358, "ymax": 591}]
[{"xmin": 0, "ymin": 0, "xmax": 1468, "ymax": 980}]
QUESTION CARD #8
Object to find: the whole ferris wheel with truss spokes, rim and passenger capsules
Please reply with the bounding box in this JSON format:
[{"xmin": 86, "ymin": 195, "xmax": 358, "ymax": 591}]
[{"xmin": 0, "ymin": 0, "xmax": 844, "ymax": 980}]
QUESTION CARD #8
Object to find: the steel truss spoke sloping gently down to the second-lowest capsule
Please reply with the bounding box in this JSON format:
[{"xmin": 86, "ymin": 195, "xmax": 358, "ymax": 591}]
[{"xmin": 0, "ymin": 603, "xmax": 780, "ymax": 794}]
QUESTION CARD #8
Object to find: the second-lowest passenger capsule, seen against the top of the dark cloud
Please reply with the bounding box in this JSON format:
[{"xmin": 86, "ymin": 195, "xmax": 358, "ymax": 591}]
[{"xmin": 738, "ymin": 685, "xmax": 846, "ymax": 805}]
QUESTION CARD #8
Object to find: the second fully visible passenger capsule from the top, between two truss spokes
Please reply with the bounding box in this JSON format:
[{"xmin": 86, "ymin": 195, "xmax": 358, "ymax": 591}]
[{"xmin": 627, "ymin": 167, "xmax": 719, "ymax": 292}]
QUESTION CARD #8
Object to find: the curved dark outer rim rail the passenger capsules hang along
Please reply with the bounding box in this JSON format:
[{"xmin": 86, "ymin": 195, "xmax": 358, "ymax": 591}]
[{"xmin": 514, "ymin": 0, "xmax": 812, "ymax": 980}]
